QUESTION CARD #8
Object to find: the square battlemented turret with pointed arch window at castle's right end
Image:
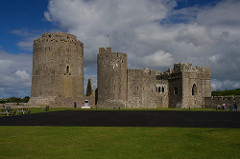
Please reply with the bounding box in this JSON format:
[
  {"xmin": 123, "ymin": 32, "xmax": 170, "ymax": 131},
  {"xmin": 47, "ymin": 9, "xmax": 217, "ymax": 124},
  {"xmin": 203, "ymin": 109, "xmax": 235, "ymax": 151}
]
[{"xmin": 169, "ymin": 63, "xmax": 211, "ymax": 108}]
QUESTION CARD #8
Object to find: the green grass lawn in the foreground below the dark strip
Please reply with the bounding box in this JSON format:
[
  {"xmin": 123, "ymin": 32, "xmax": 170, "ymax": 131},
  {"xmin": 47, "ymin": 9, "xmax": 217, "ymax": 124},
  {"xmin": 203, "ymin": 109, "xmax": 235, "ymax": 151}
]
[{"xmin": 0, "ymin": 126, "xmax": 240, "ymax": 159}]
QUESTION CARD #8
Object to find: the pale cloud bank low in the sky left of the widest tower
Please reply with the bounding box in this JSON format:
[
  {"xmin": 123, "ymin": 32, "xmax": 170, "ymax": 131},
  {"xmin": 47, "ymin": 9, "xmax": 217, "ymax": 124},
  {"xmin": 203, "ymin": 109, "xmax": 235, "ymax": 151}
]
[{"xmin": 0, "ymin": 49, "xmax": 32, "ymax": 98}]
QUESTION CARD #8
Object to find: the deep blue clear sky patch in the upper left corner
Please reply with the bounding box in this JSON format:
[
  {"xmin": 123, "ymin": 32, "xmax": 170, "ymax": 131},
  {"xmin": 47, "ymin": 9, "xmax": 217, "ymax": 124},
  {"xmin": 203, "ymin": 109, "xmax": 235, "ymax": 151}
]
[{"xmin": 0, "ymin": 0, "xmax": 55, "ymax": 54}]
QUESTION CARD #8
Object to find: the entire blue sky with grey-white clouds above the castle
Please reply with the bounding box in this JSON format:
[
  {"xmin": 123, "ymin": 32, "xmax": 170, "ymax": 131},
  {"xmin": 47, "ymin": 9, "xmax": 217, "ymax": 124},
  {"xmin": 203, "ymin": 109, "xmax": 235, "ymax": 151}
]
[{"xmin": 0, "ymin": 0, "xmax": 240, "ymax": 98}]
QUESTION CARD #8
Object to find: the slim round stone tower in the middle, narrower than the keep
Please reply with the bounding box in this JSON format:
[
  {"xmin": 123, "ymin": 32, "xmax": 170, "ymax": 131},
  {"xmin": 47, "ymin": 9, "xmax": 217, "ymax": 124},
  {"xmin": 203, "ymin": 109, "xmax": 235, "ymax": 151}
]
[{"xmin": 97, "ymin": 48, "xmax": 127, "ymax": 108}]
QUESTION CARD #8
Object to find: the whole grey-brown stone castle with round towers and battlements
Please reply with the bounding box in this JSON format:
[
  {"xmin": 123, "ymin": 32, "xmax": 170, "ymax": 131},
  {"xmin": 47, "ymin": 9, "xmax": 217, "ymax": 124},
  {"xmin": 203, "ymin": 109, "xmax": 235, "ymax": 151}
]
[{"xmin": 28, "ymin": 32, "xmax": 211, "ymax": 108}]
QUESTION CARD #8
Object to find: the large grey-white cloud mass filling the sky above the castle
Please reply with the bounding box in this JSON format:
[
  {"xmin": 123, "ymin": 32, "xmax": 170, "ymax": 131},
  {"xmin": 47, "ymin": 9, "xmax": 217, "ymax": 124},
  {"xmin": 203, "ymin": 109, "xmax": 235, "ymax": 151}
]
[{"xmin": 44, "ymin": 0, "xmax": 240, "ymax": 89}]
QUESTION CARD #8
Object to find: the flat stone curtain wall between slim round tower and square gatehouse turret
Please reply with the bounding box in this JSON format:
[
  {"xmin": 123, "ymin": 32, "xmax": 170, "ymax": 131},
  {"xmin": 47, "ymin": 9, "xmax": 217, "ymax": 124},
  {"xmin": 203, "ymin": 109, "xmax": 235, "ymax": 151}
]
[{"xmin": 127, "ymin": 69, "xmax": 168, "ymax": 108}]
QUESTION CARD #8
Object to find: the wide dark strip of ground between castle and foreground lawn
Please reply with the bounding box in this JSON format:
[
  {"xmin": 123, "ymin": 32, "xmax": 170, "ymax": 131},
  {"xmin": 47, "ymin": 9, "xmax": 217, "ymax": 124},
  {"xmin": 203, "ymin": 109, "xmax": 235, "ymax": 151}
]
[{"xmin": 0, "ymin": 111, "xmax": 240, "ymax": 128}]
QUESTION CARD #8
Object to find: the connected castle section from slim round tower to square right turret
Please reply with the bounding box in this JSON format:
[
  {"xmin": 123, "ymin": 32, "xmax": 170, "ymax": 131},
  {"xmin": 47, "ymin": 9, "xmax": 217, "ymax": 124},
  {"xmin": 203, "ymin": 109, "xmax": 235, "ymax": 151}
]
[{"xmin": 97, "ymin": 48, "xmax": 211, "ymax": 108}]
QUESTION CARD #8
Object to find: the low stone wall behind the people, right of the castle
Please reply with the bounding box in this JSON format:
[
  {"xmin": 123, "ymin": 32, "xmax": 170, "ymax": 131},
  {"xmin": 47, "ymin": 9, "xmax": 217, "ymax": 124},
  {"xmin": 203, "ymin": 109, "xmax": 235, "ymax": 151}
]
[{"xmin": 204, "ymin": 96, "xmax": 240, "ymax": 108}]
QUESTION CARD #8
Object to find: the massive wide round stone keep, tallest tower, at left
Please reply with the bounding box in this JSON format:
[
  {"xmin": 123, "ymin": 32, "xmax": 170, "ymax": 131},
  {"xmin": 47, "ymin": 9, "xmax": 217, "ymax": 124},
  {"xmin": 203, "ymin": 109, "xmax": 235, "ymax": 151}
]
[{"xmin": 29, "ymin": 32, "xmax": 84, "ymax": 105}]
